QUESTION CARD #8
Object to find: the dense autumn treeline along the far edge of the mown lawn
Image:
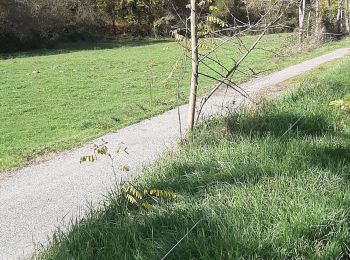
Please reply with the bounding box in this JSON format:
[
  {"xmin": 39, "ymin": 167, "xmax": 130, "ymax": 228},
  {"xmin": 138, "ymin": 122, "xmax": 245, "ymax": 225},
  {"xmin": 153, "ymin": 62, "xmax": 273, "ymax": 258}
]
[{"xmin": 0, "ymin": 0, "xmax": 349, "ymax": 51}]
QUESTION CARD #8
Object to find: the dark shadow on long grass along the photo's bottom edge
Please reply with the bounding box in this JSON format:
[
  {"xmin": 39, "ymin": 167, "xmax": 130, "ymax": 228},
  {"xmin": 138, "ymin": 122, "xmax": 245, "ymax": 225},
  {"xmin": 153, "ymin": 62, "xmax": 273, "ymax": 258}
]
[{"xmin": 49, "ymin": 189, "xmax": 306, "ymax": 260}]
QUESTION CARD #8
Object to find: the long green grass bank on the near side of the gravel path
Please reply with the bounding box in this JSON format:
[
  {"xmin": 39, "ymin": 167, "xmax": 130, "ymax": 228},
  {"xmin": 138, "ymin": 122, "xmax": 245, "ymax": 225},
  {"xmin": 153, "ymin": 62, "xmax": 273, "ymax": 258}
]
[{"xmin": 37, "ymin": 58, "xmax": 350, "ymax": 259}]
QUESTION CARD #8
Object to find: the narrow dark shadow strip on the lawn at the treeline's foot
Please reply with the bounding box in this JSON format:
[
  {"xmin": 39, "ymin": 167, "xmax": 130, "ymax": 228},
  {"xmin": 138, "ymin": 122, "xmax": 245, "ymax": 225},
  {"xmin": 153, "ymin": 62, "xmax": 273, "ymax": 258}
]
[{"xmin": 0, "ymin": 37, "xmax": 172, "ymax": 60}]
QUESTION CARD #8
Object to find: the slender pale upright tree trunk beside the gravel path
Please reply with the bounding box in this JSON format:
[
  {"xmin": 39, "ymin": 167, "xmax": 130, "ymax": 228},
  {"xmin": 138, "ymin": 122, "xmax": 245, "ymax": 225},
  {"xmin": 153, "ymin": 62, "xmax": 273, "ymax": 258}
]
[{"xmin": 188, "ymin": 0, "xmax": 198, "ymax": 131}]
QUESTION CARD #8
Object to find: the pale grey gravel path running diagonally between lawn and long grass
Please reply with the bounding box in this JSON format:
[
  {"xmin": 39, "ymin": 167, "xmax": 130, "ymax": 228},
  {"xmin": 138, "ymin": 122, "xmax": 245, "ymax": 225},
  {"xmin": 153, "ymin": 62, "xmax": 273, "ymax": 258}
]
[{"xmin": 0, "ymin": 48, "xmax": 350, "ymax": 260}]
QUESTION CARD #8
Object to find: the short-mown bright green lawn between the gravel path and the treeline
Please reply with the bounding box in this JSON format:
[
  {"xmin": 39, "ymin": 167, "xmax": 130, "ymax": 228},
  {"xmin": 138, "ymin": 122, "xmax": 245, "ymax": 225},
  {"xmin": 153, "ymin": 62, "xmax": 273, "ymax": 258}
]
[{"xmin": 0, "ymin": 34, "xmax": 349, "ymax": 171}]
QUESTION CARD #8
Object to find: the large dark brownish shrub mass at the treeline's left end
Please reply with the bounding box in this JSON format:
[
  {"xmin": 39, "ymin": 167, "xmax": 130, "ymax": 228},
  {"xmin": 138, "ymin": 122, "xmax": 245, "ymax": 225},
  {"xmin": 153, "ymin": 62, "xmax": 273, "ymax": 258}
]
[{"xmin": 0, "ymin": 0, "xmax": 104, "ymax": 51}]
